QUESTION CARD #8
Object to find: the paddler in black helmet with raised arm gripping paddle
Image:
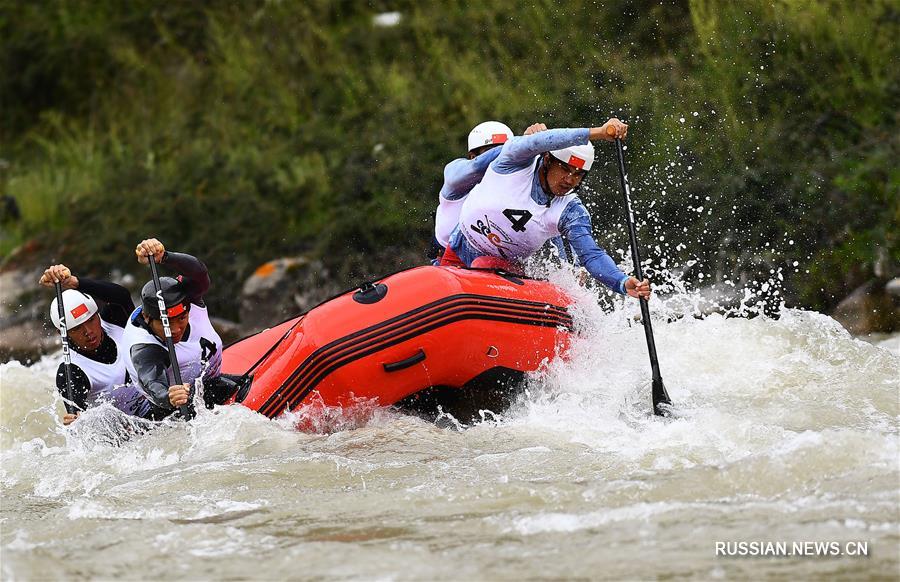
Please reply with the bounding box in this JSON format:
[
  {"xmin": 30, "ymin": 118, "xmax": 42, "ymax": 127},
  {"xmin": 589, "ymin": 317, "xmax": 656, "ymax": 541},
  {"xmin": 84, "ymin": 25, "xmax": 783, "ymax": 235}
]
[{"xmin": 124, "ymin": 238, "xmax": 237, "ymax": 415}]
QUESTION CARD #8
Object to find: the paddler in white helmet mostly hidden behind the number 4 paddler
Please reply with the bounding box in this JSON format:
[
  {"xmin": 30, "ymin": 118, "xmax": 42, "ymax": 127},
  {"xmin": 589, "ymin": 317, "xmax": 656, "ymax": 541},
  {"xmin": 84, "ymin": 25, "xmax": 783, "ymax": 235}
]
[{"xmin": 429, "ymin": 121, "xmax": 565, "ymax": 264}]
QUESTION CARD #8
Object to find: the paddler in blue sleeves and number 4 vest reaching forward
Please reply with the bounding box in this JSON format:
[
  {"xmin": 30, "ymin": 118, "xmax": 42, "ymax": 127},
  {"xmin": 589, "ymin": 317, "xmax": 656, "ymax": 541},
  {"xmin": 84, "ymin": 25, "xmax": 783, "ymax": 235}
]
[{"xmin": 442, "ymin": 118, "xmax": 650, "ymax": 297}]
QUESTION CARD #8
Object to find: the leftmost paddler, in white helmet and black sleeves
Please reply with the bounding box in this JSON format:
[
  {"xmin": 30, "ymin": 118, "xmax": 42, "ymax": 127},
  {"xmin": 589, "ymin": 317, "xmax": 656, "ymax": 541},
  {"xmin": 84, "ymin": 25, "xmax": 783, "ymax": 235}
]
[{"xmin": 38, "ymin": 264, "xmax": 154, "ymax": 425}]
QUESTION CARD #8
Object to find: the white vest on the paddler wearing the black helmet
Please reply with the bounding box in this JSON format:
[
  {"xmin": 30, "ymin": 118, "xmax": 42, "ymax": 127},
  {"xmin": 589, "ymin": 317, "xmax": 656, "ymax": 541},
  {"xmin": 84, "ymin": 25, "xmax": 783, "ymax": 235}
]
[{"xmin": 125, "ymin": 303, "xmax": 222, "ymax": 386}]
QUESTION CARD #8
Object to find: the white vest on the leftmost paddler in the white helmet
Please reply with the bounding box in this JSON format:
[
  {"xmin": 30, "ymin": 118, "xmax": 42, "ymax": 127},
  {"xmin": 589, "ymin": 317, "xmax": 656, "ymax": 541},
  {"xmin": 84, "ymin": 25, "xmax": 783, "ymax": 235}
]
[{"xmin": 62, "ymin": 317, "xmax": 149, "ymax": 416}]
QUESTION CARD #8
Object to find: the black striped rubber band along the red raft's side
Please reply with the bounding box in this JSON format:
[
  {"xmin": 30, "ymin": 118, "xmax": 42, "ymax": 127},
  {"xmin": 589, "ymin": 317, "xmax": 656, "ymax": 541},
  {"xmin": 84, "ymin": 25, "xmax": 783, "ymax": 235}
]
[{"xmin": 259, "ymin": 294, "xmax": 572, "ymax": 417}]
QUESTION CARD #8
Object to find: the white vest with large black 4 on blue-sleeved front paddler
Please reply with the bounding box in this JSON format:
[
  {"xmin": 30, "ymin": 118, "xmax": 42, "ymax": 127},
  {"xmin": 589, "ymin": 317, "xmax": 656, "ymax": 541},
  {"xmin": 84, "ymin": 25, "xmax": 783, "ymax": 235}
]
[{"xmin": 459, "ymin": 156, "xmax": 576, "ymax": 259}]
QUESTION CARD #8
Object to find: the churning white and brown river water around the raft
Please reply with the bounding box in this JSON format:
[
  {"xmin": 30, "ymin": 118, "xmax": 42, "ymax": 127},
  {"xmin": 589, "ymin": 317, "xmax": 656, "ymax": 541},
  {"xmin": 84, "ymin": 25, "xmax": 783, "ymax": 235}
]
[{"xmin": 0, "ymin": 276, "xmax": 900, "ymax": 580}]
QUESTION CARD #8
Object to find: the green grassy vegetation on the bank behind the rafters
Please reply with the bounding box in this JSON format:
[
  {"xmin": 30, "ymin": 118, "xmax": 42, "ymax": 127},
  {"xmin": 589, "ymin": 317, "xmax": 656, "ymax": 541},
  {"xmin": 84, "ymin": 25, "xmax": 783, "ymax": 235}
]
[{"xmin": 0, "ymin": 0, "xmax": 900, "ymax": 315}]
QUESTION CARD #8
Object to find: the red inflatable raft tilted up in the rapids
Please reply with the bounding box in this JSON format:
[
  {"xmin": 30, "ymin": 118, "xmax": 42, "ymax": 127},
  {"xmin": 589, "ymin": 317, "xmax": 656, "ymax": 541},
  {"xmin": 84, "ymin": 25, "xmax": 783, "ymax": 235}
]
[{"xmin": 223, "ymin": 266, "xmax": 572, "ymax": 418}]
